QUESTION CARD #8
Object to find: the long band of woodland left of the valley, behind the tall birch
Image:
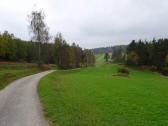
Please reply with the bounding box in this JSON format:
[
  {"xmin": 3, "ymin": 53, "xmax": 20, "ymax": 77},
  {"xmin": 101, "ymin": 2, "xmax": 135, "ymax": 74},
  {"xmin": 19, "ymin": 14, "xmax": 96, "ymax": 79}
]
[{"xmin": 0, "ymin": 31, "xmax": 95, "ymax": 69}]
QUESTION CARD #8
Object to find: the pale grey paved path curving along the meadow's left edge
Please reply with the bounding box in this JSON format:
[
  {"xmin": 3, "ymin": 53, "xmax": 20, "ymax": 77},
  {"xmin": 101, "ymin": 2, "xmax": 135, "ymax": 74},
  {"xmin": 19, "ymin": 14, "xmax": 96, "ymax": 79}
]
[{"xmin": 0, "ymin": 71, "xmax": 52, "ymax": 126}]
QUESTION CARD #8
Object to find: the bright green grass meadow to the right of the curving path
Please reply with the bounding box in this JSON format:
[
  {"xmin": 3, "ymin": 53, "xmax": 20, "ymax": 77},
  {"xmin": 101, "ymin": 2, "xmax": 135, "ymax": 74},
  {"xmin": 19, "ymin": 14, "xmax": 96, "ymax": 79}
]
[{"xmin": 39, "ymin": 56, "xmax": 168, "ymax": 126}]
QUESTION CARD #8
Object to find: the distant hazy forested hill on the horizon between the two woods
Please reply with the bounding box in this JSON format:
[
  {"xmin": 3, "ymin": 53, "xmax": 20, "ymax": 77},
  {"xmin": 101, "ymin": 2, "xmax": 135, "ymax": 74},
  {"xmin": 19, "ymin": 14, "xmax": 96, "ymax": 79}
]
[{"xmin": 92, "ymin": 45, "xmax": 127, "ymax": 54}]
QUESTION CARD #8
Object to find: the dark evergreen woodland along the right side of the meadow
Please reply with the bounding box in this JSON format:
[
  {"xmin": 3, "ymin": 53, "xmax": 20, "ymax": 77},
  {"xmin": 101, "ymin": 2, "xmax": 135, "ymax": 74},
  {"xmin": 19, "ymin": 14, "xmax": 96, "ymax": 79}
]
[{"xmin": 104, "ymin": 39, "xmax": 168, "ymax": 75}]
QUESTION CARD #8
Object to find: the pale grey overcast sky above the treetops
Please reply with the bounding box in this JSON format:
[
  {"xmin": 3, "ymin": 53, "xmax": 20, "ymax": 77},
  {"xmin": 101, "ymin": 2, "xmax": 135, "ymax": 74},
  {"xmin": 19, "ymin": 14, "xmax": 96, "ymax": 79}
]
[{"xmin": 0, "ymin": 0, "xmax": 168, "ymax": 48}]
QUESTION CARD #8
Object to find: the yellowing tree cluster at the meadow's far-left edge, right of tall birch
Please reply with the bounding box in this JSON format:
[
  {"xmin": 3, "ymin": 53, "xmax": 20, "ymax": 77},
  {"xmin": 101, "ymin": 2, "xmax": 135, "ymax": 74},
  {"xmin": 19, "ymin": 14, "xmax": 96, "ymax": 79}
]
[{"xmin": 54, "ymin": 33, "xmax": 96, "ymax": 69}]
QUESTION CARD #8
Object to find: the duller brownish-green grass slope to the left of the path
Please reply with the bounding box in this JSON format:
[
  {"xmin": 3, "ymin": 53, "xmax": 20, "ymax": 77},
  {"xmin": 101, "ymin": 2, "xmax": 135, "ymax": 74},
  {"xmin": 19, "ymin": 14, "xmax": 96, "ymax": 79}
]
[{"xmin": 0, "ymin": 63, "xmax": 46, "ymax": 90}]
